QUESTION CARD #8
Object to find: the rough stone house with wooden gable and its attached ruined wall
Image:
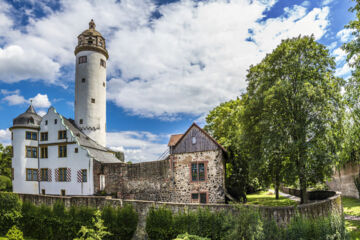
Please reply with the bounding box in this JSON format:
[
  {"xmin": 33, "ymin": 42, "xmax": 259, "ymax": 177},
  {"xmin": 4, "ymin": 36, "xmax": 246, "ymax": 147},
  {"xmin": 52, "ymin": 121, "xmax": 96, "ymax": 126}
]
[{"xmin": 94, "ymin": 123, "xmax": 226, "ymax": 203}]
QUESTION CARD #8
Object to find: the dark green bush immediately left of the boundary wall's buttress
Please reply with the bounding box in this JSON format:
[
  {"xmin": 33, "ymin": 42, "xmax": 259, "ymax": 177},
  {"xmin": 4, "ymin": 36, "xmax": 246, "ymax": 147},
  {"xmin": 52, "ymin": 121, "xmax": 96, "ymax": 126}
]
[{"xmin": 102, "ymin": 205, "xmax": 139, "ymax": 240}]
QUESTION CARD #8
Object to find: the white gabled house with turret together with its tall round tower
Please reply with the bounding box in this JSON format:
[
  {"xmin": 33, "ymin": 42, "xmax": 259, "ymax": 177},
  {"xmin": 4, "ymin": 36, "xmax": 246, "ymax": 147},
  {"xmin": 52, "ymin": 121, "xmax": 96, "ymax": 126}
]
[{"xmin": 11, "ymin": 20, "xmax": 121, "ymax": 195}]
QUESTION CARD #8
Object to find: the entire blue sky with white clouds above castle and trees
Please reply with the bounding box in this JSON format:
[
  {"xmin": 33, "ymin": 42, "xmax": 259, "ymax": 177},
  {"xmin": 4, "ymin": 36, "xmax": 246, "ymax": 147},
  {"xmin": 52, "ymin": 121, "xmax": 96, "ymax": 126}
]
[{"xmin": 0, "ymin": 0, "xmax": 353, "ymax": 162}]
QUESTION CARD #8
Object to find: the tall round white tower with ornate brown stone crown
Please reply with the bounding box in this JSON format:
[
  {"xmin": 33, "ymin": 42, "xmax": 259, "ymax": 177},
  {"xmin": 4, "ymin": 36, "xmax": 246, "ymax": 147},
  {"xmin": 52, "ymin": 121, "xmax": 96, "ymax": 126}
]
[{"xmin": 75, "ymin": 20, "xmax": 109, "ymax": 146}]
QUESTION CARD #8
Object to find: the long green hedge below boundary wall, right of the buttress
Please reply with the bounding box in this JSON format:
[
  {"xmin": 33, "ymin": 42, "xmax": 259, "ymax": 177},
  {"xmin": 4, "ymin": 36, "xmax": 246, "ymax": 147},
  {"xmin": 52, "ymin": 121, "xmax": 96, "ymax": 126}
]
[{"xmin": 146, "ymin": 204, "xmax": 347, "ymax": 240}]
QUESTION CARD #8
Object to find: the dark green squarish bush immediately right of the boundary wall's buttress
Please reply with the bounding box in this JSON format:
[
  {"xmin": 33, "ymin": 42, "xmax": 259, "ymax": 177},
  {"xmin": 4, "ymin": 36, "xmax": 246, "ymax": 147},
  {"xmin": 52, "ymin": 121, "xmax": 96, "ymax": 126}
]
[{"xmin": 145, "ymin": 207, "xmax": 174, "ymax": 240}]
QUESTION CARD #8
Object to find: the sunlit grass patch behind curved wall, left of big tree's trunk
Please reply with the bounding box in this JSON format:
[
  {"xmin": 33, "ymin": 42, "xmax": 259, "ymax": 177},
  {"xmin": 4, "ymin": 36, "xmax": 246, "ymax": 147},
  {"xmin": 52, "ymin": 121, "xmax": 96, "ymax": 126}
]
[{"xmin": 246, "ymin": 191, "xmax": 297, "ymax": 207}]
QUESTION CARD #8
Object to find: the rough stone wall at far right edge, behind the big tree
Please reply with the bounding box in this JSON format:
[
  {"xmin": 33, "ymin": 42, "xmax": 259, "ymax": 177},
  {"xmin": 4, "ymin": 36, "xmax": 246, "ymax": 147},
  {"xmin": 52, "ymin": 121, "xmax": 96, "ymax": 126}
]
[{"xmin": 327, "ymin": 163, "xmax": 360, "ymax": 198}]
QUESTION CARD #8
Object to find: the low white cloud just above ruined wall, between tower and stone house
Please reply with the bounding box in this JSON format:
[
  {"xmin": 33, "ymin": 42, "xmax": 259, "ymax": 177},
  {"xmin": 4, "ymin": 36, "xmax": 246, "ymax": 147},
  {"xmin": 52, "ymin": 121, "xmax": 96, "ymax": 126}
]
[{"xmin": 107, "ymin": 131, "xmax": 167, "ymax": 162}]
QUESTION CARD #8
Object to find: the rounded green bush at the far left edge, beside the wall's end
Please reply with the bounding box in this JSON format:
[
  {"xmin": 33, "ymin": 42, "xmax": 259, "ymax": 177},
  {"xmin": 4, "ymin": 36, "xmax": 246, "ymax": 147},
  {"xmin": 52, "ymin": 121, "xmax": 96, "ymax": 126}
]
[{"xmin": 0, "ymin": 192, "xmax": 21, "ymax": 235}]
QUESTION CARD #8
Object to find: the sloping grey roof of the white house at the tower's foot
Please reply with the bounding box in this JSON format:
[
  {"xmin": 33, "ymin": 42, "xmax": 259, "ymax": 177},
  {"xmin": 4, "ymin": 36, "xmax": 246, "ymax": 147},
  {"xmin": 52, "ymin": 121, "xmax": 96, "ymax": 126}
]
[{"xmin": 62, "ymin": 117, "xmax": 122, "ymax": 163}]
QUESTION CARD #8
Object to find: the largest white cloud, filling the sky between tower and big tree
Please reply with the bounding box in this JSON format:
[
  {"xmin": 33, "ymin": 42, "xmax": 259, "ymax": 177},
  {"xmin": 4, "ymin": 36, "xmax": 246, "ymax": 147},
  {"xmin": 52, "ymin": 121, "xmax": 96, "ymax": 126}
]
[{"xmin": 108, "ymin": 1, "xmax": 329, "ymax": 117}]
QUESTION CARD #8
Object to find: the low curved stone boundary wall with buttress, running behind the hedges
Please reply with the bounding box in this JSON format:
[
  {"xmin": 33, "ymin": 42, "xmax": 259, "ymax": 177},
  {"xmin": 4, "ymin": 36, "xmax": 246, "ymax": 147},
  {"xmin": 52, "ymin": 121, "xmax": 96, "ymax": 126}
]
[{"xmin": 18, "ymin": 192, "xmax": 343, "ymax": 240}]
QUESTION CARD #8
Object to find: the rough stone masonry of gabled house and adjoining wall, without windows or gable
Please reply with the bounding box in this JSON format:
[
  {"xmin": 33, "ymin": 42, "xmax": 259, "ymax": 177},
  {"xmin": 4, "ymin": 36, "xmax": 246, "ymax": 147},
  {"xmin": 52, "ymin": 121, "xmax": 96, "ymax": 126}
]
[{"xmin": 94, "ymin": 150, "xmax": 225, "ymax": 203}]
